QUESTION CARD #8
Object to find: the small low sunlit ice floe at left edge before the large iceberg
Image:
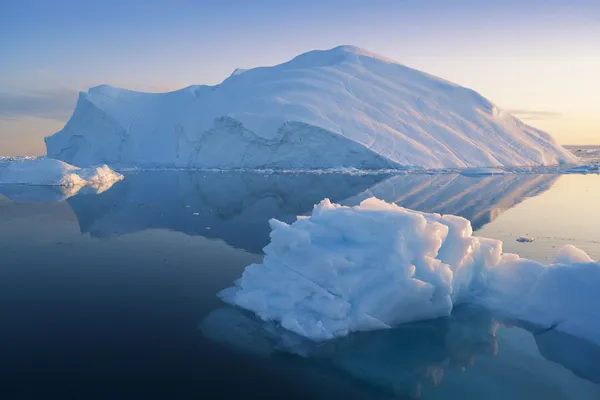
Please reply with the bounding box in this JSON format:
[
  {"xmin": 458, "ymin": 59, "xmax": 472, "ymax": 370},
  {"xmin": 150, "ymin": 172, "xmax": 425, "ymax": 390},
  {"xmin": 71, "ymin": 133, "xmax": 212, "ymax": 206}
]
[{"xmin": 0, "ymin": 158, "xmax": 123, "ymax": 187}]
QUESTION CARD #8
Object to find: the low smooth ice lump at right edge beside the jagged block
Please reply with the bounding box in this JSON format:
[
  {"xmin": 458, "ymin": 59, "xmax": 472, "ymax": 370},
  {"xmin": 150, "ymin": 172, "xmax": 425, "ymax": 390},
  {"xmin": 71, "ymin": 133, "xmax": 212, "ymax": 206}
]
[{"xmin": 478, "ymin": 246, "xmax": 600, "ymax": 344}]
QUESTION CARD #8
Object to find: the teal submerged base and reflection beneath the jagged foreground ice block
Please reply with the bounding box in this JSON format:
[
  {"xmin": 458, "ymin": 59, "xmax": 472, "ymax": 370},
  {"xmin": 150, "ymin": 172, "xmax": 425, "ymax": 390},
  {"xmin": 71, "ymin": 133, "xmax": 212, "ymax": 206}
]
[{"xmin": 200, "ymin": 307, "xmax": 498, "ymax": 398}]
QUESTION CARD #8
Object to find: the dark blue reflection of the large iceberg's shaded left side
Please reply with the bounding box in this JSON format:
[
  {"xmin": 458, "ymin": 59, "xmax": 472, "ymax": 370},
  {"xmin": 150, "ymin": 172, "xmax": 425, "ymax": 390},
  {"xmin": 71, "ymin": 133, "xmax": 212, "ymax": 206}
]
[{"xmin": 68, "ymin": 172, "xmax": 385, "ymax": 253}]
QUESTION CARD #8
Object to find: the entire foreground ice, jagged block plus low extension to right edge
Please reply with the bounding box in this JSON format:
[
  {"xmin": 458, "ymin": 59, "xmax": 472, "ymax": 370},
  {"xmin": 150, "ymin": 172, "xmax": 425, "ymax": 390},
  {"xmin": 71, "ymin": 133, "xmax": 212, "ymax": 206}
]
[{"xmin": 219, "ymin": 198, "xmax": 600, "ymax": 342}]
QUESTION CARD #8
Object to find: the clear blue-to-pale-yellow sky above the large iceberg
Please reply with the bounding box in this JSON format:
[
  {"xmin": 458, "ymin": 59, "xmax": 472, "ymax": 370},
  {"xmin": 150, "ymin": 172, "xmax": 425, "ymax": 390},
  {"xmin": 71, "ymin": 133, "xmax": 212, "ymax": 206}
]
[{"xmin": 0, "ymin": 0, "xmax": 600, "ymax": 155}]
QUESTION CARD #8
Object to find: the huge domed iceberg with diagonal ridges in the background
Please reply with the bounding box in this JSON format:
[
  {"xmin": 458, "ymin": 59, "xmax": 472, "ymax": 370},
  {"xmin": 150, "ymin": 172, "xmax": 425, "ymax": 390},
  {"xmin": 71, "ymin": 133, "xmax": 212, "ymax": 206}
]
[{"xmin": 46, "ymin": 46, "xmax": 578, "ymax": 173}]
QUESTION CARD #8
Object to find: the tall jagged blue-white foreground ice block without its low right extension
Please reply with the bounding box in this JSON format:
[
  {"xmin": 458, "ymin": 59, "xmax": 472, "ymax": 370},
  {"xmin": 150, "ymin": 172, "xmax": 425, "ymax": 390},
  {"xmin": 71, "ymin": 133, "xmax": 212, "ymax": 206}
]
[{"xmin": 220, "ymin": 198, "xmax": 501, "ymax": 340}]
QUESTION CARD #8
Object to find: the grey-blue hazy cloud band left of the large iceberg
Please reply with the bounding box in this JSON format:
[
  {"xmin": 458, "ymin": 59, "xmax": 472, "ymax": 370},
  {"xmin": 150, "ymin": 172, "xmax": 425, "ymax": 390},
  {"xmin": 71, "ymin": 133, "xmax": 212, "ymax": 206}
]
[{"xmin": 0, "ymin": 89, "xmax": 77, "ymax": 121}]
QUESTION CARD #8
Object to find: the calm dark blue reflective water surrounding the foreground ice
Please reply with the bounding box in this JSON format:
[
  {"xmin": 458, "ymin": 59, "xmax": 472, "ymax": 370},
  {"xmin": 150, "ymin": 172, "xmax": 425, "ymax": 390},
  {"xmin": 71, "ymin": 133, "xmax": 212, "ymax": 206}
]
[{"xmin": 0, "ymin": 172, "xmax": 600, "ymax": 400}]
